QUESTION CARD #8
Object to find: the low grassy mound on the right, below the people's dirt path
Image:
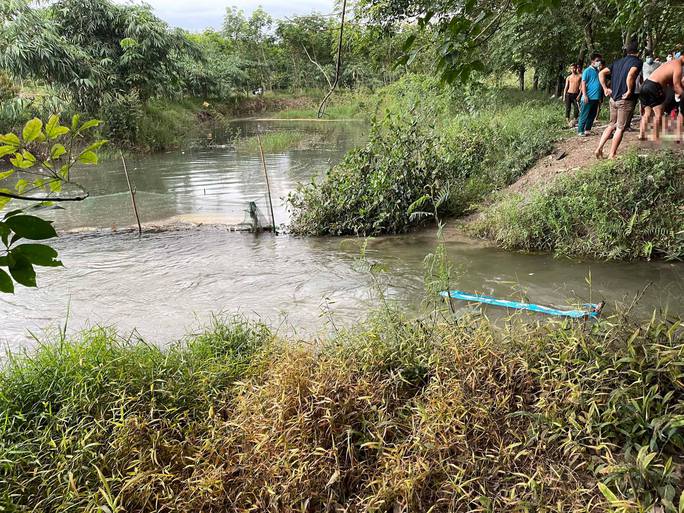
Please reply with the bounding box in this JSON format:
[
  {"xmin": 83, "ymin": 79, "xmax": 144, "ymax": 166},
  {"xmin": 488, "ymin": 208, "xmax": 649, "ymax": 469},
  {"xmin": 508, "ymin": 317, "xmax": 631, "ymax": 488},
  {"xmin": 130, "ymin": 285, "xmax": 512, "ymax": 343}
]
[{"xmin": 470, "ymin": 152, "xmax": 684, "ymax": 260}]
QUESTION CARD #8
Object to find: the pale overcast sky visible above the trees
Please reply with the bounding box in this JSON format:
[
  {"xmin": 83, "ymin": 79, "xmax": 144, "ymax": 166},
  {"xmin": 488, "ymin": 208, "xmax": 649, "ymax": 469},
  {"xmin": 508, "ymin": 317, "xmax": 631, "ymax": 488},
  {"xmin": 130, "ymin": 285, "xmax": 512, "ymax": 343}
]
[{"xmin": 116, "ymin": 0, "xmax": 334, "ymax": 31}]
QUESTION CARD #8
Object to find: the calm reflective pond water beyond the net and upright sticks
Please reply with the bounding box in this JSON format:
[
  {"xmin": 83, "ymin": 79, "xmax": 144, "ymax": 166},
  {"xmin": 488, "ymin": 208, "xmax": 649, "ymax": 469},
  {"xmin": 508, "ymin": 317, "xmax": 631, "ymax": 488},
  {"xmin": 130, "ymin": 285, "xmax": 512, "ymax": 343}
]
[{"xmin": 44, "ymin": 121, "xmax": 365, "ymax": 229}]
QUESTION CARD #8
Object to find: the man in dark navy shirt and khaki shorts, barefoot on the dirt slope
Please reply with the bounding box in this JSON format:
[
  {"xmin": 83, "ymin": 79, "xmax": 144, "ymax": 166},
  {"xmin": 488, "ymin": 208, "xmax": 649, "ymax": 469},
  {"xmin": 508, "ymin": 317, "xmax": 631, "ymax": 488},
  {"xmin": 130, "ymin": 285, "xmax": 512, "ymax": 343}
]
[{"xmin": 594, "ymin": 42, "xmax": 644, "ymax": 159}]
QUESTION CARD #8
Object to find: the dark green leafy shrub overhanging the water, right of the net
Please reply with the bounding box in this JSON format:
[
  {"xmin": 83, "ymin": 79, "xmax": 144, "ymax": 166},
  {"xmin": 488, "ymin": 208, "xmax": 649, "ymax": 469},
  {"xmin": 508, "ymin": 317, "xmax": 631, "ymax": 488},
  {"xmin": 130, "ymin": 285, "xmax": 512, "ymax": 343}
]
[{"xmin": 290, "ymin": 104, "xmax": 448, "ymax": 235}]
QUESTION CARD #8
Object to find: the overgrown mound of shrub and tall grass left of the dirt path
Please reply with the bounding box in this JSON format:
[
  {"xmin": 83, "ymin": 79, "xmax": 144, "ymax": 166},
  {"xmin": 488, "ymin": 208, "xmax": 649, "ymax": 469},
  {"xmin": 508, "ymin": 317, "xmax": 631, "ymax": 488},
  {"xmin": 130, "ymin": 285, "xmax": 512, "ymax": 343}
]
[{"xmin": 289, "ymin": 77, "xmax": 561, "ymax": 236}]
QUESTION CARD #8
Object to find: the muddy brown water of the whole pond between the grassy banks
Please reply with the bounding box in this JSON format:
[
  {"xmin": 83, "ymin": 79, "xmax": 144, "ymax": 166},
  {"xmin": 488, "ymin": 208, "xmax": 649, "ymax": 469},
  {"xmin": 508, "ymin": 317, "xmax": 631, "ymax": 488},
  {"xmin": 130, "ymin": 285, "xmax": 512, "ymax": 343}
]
[{"xmin": 0, "ymin": 121, "xmax": 684, "ymax": 351}]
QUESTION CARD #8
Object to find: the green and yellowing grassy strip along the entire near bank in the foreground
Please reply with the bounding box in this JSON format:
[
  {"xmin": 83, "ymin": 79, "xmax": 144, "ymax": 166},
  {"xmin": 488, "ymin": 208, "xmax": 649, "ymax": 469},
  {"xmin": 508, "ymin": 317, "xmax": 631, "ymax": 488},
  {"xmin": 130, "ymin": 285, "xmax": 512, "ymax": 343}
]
[{"xmin": 0, "ymin": 313, "xmax": 684, "ymax": 513}]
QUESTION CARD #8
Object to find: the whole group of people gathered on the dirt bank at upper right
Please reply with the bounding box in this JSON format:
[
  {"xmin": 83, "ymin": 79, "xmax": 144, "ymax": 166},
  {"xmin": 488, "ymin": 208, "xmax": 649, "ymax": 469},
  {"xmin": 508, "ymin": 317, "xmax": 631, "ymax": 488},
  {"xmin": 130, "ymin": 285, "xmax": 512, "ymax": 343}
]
[{"xmin": 564, "ymin": 43, "xmax": 684, "ymax": 159}]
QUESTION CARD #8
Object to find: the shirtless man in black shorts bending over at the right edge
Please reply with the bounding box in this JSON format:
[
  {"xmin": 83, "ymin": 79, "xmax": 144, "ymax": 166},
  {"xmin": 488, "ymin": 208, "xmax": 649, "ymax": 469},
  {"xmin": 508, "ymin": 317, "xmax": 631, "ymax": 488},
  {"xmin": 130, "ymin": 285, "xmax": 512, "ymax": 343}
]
[{"xmin": 641, "ymin": 56, "xmax": 684, "ymax": 141}]
